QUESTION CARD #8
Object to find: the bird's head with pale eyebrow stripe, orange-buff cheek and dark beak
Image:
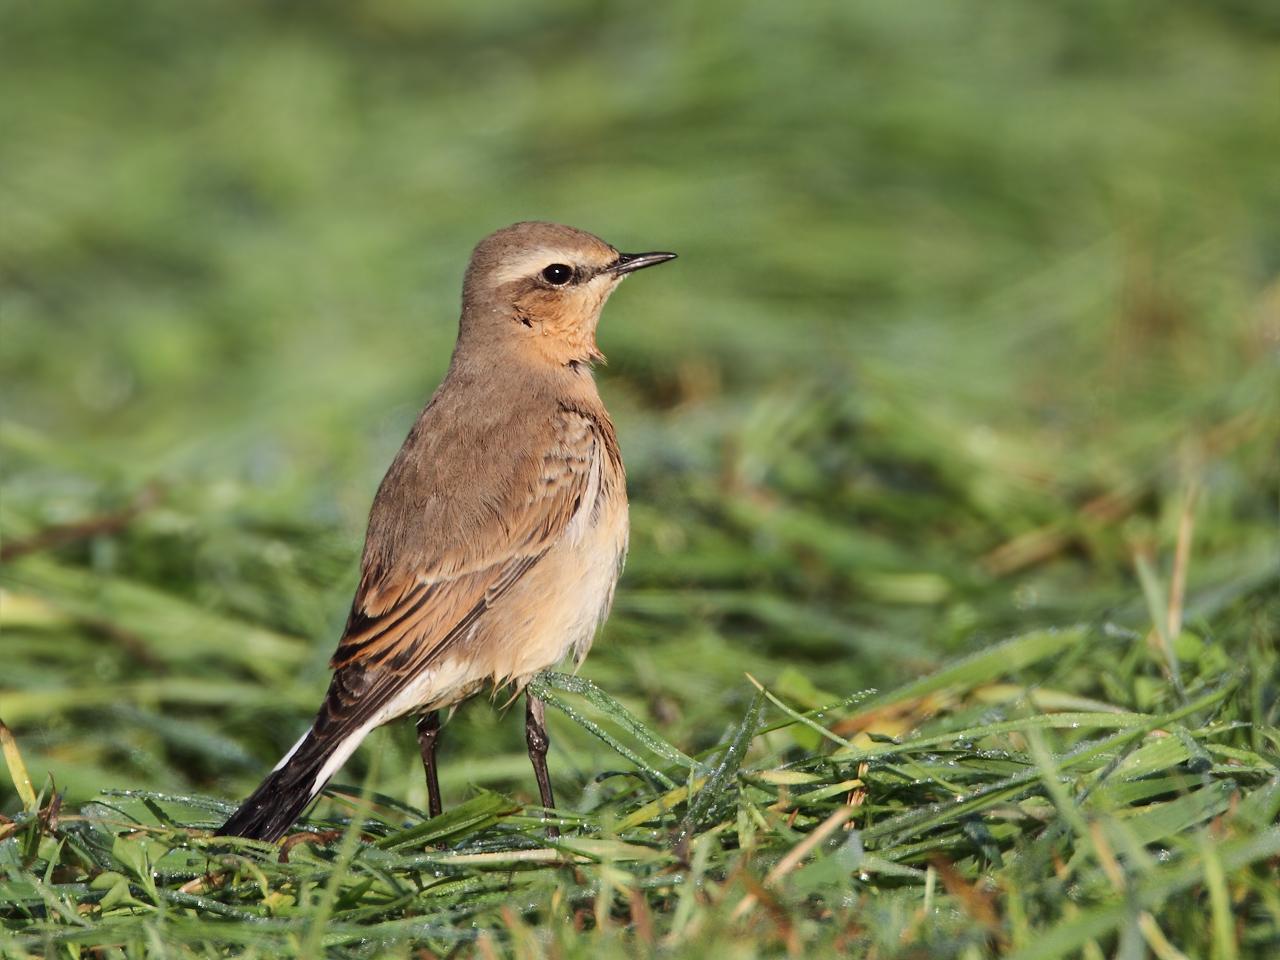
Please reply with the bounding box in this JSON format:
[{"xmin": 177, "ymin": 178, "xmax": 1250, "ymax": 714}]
[{"xmin": 461, "ymin": 221, "xmax": 676, "ymax": 366}]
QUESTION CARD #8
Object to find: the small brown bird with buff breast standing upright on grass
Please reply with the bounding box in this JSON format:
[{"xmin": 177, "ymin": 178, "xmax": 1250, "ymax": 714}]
[{"xmin": 218, "ymin": 223, "xmax": 676, "ymax": 840}]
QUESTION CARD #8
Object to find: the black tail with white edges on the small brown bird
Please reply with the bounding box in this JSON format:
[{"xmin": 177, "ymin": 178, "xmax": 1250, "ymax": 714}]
[{"xmin": 218, "ymin": 722, "xmax": 369, "ymax": 841}]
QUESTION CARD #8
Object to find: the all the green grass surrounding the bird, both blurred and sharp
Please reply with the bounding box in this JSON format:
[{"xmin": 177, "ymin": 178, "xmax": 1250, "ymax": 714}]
[{"xmin": 0, "ymin": 0, "xmax": 1280, "ymax": 960}]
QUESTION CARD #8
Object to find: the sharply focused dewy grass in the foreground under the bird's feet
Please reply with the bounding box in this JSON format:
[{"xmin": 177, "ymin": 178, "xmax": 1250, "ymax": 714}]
[{"xmin": 4, "ymin": 626, "xmax": 1280, "ymax": 957}]
